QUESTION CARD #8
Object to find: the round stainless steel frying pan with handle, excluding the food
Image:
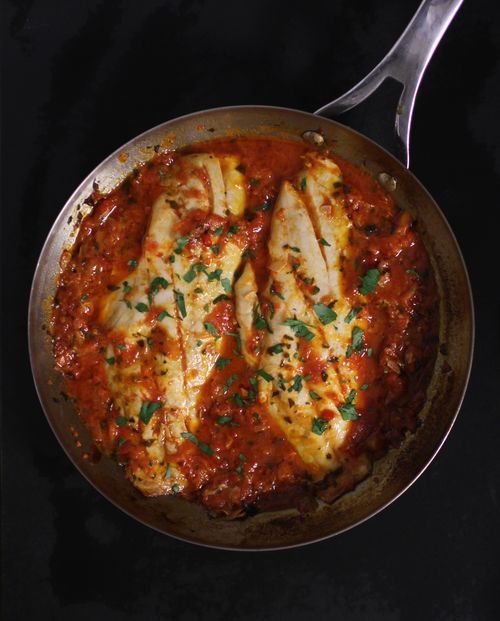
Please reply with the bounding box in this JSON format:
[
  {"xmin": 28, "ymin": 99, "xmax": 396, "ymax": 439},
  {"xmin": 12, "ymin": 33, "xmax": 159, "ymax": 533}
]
[{"xmin": 29, "ymin": 0, "xmax": 474, "ymax": 550}]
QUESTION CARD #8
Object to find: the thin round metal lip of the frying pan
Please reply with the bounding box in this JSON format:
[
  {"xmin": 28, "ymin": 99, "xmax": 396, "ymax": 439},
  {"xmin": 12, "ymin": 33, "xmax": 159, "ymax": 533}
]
[{"xmin": 27, "ymin": 105, "xmax": 475, "ymax": 552}]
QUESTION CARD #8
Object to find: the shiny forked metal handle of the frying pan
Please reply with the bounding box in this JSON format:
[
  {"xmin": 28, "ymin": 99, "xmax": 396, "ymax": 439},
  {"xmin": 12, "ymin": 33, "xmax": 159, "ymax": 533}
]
[{"xmin": 315, "ymin": 0, "xmax": 463, "ymax": 168}]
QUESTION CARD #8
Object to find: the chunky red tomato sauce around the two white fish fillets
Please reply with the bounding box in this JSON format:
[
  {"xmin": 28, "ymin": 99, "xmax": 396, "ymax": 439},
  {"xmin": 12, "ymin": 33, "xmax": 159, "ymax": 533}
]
[{"xmin": 51, "ymin": 138, "xmax": 438, "ymax": 515}]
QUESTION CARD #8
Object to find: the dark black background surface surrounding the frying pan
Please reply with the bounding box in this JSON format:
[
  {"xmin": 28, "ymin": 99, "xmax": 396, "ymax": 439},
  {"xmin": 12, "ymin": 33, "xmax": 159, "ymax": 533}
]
[{"xmin": 2, "ymin": 0, "xmax": 500, "ymax": 621}]
